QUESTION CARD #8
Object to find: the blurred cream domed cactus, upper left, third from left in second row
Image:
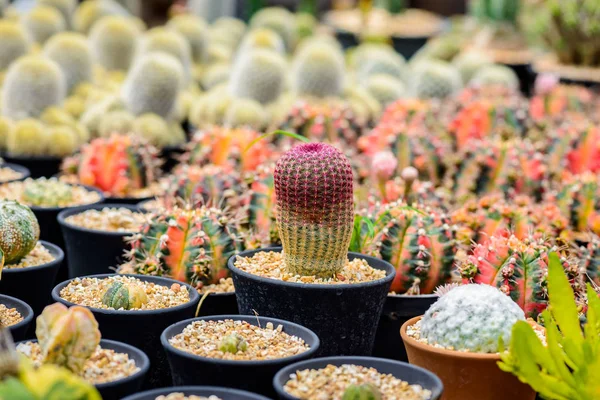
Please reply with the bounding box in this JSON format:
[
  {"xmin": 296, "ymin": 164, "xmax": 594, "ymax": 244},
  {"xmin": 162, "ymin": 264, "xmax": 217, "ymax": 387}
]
[{"xmin": 90, "ymin": 16, "xmax": 141, "ymax": 71}]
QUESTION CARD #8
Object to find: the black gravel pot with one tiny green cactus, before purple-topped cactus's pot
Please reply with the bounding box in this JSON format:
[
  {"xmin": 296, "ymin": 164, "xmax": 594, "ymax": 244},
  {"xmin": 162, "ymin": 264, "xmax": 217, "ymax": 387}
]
[{"xmin": 161, "ymin": 315, "xmax": 319, "ymax": 396}]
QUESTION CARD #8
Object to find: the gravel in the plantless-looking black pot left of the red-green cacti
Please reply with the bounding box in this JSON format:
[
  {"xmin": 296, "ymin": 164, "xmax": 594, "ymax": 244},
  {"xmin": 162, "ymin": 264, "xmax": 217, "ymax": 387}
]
[{"xmin": 65, "ymin": 207, "xmax": 146, "ymax": 232}]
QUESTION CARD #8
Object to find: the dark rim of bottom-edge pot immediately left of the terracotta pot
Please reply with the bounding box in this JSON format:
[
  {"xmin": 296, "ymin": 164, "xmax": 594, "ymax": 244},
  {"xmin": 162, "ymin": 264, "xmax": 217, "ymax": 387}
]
[{"xmin": 273, "ymin": 356, "xmax": 444, "ymax": 399}]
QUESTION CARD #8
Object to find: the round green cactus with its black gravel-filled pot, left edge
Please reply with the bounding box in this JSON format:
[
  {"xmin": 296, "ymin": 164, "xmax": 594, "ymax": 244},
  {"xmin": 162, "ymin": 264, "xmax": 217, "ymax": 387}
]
[{"xmin": 0, "ymin": 200, "xmax": 64, "ymax": 315}]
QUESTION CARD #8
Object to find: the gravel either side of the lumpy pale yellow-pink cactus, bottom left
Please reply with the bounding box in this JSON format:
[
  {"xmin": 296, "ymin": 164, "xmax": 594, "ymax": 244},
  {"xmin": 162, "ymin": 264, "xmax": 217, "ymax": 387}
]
[{"xmin": 17, "ymin": 342, "xmax": 140, "ymax": 385}]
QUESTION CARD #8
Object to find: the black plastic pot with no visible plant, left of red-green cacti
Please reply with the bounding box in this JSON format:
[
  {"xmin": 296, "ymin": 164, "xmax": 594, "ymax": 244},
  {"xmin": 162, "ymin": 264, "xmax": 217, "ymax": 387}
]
[{"xmin": 58, "ymin": 204, "xmax": 143, "ymax": 278}]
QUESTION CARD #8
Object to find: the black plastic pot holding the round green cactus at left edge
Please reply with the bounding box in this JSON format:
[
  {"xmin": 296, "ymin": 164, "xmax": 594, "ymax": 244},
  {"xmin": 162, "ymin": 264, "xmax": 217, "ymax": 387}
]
[{"xmin": 0, "ymin": 240, "xmax": 64, "ymax": 316}]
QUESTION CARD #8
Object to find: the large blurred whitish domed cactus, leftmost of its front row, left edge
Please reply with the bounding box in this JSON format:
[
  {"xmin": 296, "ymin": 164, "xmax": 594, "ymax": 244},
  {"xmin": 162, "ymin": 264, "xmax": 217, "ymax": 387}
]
[{"xmin": 0, "ymin": 56, "xmax": 66, "ymax": 119}]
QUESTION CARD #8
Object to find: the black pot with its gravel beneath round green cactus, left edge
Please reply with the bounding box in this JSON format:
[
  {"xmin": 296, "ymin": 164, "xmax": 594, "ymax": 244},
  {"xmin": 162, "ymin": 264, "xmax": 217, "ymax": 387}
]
[{"xmin": 0, "ymin": 240, "xmax": 64, "ymax": 315}]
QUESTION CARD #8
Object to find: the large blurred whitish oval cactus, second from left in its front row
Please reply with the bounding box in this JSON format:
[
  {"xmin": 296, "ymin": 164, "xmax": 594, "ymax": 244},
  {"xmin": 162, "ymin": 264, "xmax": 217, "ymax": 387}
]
[{"xmin": 122, "ymin": 53, "xmax": 184, "ymax": 119}]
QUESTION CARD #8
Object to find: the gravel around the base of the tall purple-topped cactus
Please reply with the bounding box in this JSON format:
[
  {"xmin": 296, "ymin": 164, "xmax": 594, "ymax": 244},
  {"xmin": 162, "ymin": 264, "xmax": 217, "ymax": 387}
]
[{"xmin": 234, "ymin": 251, "xmax": 385, "ymax": 285}]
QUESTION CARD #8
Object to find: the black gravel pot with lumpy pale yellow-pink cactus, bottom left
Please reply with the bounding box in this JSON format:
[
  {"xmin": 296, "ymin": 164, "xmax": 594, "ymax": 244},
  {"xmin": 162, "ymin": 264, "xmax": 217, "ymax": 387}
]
[{"xmin": 17, "ymin": 303, "xmax": 150, "ymax": 399}]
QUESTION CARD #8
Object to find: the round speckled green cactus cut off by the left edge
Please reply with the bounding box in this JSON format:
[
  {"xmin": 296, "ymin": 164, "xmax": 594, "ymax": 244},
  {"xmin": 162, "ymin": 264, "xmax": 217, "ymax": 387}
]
[{"xmin": 0, "ymin": 200, "xmax": 40, "ymax": 270}]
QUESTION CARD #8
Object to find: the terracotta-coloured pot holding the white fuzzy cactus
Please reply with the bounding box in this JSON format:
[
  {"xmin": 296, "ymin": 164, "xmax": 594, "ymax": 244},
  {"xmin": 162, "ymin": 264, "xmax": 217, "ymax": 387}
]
[{"xmin": 400, "ymin": 317, "xmax": 535, "ymax": 400}]
